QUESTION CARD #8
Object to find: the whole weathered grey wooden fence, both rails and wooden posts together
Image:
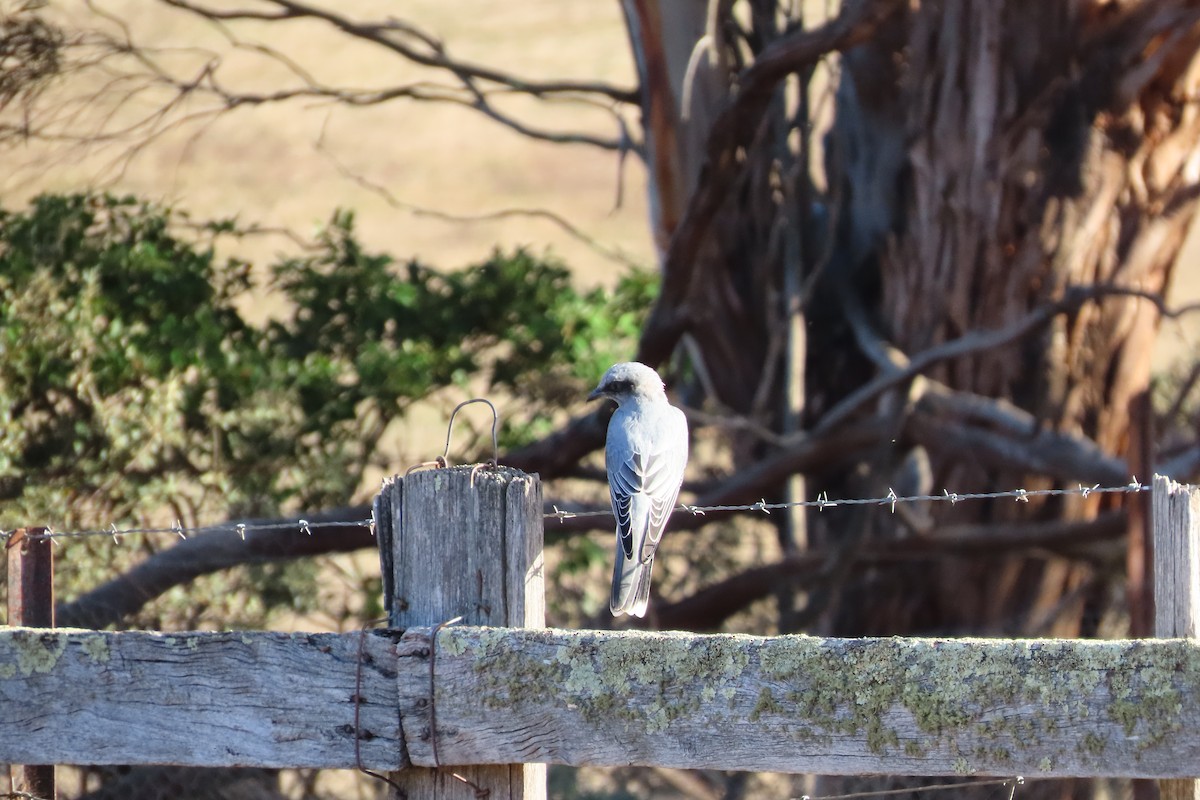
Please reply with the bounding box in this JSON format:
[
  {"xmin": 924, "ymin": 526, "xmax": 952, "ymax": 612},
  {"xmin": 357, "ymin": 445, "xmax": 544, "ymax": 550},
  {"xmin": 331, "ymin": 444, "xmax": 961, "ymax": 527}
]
[{"xmin": 0, "ymin": 470, "xmax": 1200, "ymax": 798}]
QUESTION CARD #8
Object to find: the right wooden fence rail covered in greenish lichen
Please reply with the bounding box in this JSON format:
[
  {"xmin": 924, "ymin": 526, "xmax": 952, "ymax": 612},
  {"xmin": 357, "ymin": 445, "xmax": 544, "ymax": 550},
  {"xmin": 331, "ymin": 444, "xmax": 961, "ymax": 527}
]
[{"xmin": 400, "ymin": 627, "xmax": 1200, "ymax": 777}]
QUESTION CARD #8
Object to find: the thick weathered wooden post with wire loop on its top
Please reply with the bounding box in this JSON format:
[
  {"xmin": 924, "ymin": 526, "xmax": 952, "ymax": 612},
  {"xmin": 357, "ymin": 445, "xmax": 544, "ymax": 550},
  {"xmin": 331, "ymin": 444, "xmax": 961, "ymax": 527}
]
[{"xmin": 374, "ymin": 467, "xmax": 546, "ymax": 800}]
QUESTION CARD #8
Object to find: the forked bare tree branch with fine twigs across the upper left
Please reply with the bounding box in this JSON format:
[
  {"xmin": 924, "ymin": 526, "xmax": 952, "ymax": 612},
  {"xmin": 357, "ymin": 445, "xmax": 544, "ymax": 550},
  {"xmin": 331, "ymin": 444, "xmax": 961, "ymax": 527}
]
[{"xmin": 7, "ymin": 0, "xmax": 640, "ymax": 182}]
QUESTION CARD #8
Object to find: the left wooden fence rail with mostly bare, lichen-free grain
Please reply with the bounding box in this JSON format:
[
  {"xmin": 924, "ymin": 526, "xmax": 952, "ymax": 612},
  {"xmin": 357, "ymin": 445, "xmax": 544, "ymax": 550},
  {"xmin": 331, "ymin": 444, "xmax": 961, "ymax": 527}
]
[{"xmin": 0, "ymin": 628, "xmax": 400, "ymax": 769}]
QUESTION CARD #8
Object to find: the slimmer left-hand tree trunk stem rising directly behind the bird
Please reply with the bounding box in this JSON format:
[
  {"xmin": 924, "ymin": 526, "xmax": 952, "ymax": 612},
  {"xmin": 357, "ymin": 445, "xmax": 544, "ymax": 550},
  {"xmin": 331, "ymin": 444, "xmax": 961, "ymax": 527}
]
[{"xmin": 624, "ymin": 0, "xmax": 816, "ymax": 412}]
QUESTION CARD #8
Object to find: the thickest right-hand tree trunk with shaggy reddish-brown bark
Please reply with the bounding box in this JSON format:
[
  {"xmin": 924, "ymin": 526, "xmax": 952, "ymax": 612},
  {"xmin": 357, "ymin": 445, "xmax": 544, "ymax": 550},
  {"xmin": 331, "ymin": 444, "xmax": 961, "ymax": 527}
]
[{"xmin": 833, "ymin": 0, "xmax": 1200, "ymax": 636}]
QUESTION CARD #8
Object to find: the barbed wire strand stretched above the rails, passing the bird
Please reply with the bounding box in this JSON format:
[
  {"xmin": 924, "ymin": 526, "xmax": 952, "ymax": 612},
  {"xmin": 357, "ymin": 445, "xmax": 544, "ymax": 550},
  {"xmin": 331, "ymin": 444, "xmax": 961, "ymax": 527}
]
[{"xmin": 0, "ymin": 476, "xmax": 1151, "ymax": 545}]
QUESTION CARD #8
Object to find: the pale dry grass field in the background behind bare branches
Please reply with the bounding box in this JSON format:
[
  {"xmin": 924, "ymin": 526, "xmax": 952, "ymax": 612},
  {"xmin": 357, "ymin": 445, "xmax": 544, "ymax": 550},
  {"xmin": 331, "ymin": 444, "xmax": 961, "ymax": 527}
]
[{"xmin": 0, "ymin": 0, "xmax": 653, "ymax": 282}]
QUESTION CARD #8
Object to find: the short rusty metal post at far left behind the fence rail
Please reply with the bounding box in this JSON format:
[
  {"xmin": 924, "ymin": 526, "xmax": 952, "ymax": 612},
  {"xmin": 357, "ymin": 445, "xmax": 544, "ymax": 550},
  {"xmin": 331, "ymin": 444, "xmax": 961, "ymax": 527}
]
[{"xmin": 7, "ymin": 528, "xmax": 56, "ymax": 800}]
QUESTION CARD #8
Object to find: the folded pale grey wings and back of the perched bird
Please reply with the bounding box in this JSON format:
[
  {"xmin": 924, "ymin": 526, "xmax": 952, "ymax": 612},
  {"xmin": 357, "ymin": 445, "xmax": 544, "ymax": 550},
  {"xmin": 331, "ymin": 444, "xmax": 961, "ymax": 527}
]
[{"xmin": 608, "ymin": 409, "xmax": 688, "ymax": 563}]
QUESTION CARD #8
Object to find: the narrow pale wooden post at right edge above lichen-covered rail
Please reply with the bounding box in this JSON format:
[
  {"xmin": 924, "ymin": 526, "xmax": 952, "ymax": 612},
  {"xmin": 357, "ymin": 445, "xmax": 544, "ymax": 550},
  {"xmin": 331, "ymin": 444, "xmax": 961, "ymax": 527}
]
[{"xmin": 1152, "ymin": 475, "xmax": 1200, "ymax": 800}]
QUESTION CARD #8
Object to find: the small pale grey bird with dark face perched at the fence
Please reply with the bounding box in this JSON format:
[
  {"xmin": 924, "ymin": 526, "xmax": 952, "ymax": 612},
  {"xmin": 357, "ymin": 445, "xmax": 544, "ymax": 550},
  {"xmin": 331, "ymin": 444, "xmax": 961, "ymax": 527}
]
[{"xmin": 588, "ymin": 361, "xmax": 688, "ymax": 616}]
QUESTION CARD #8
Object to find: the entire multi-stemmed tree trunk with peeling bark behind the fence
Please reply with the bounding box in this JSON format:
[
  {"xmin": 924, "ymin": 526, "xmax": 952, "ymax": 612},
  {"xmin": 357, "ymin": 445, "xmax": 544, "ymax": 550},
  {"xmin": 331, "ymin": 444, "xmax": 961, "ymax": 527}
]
[{"xmin": 626, "ymin": 0, "xmax": 1200, "ymax": 793}]
